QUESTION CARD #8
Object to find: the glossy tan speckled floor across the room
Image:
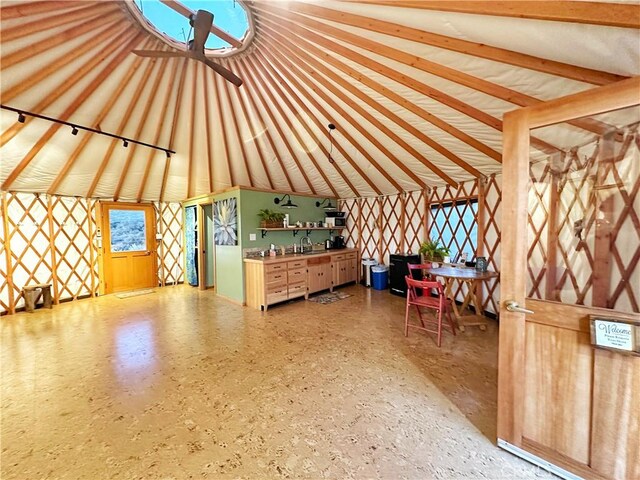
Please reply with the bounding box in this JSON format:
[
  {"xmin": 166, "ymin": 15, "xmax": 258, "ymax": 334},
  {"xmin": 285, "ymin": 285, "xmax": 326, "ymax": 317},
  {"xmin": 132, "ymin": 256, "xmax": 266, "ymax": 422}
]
[{"xmin": 0, "ymin": 286, "xmax": 551, "ymax": 479}]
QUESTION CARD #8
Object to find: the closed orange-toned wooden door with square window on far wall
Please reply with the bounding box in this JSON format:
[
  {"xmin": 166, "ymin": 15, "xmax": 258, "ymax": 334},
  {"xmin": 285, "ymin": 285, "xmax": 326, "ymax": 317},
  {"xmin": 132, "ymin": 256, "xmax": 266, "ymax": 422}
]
[{"xmin": 101, "ymin": 203, "xmax": 157, "ymax": 293}]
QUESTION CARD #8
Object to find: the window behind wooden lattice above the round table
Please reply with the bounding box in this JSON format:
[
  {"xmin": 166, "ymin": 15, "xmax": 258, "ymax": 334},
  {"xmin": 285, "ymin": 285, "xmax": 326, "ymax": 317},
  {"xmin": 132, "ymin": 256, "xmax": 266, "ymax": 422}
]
[{"xmin": 430, "ymin": 198, "xmax": 478, "ymax": 260}]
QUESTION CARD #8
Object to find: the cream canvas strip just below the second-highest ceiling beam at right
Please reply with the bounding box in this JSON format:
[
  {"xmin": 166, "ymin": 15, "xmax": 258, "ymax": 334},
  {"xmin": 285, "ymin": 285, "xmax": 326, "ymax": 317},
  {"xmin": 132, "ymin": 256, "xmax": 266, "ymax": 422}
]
[{"xmin": 323, "ymin": 16, "xmax": 593, "ymax": 102}]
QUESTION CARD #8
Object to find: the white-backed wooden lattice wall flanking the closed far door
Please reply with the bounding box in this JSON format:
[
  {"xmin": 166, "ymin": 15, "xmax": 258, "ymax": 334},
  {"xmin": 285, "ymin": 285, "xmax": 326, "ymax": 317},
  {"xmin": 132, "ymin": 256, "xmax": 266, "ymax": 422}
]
[{"xmin": 0, "ymin": 192, "xmax": 183, "ymax": 313}]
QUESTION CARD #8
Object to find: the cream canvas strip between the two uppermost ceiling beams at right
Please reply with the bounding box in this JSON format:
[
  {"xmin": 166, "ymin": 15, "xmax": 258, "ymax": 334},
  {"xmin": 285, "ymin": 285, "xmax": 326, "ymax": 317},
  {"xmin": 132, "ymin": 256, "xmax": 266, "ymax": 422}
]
[{"xmin": 322, "ymin": 1, "xmax": 640, "ymax": 76}]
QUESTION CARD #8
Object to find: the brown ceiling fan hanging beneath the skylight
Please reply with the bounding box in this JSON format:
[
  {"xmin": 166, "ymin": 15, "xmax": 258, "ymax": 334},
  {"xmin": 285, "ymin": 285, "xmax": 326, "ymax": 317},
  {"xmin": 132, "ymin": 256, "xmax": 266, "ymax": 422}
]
[{"xmin": 133, "ymin": 10, "xmax": 242, "ymax": 87}]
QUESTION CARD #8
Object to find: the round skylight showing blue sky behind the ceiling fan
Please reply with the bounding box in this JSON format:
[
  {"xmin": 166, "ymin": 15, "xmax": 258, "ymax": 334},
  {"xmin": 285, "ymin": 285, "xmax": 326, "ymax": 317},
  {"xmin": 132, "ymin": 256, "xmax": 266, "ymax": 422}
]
[{"xmin": 135, "ymin": 0, "xmax": 250, "ymax": 53}]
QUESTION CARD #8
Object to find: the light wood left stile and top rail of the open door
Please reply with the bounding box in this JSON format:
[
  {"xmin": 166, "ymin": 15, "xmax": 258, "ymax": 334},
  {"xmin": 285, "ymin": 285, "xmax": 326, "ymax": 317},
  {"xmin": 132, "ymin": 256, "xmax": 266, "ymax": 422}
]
[{"xmin": 497, "ymin": 77, "xmax": 640, "ymax": 447}]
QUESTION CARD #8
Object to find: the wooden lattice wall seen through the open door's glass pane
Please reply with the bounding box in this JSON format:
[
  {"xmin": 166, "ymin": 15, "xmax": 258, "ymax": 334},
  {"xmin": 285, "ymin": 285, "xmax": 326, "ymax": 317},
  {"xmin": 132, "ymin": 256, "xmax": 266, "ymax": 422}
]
[{"xmin": 527, "ymin": 126, "xmax": 640, "ymax": 312}]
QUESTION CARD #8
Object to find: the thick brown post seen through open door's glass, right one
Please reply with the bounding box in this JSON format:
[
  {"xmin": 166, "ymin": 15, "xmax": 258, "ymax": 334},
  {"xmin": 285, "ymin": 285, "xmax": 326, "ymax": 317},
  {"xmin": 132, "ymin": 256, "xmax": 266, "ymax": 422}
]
[{"xmin": 585, "ymin": 131, "xmax": 616, "ymax": 308}]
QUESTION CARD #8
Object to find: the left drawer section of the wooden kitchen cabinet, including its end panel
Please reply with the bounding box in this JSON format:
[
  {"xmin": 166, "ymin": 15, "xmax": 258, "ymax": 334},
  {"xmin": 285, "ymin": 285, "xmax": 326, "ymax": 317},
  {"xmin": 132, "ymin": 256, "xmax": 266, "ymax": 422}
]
[{"xmin": 245, "ymin": 259, "xmax": 307, "ymax": 310}]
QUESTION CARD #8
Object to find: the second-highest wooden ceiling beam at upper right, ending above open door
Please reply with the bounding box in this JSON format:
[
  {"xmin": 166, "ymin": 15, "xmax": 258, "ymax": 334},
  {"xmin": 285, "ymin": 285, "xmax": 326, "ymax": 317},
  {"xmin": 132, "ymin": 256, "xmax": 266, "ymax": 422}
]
[{"xmin": 287, "ymin": 2, "xmax": 626, "ymax": 85}]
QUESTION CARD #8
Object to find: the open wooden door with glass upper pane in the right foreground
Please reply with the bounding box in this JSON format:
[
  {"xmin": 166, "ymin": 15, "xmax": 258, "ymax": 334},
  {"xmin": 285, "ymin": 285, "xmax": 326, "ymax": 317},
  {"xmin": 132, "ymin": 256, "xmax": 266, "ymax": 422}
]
[{"xmin": 498, "ymin": 78, "xmax": 640, "ymax": 480}]
